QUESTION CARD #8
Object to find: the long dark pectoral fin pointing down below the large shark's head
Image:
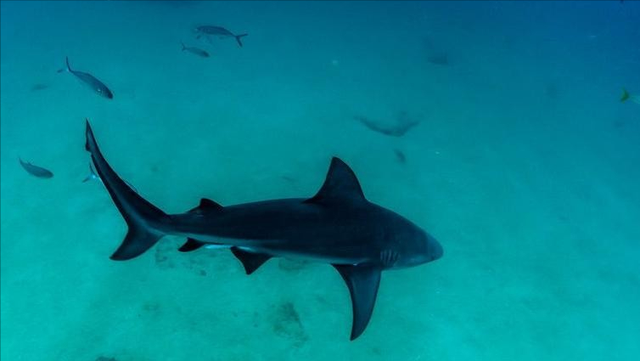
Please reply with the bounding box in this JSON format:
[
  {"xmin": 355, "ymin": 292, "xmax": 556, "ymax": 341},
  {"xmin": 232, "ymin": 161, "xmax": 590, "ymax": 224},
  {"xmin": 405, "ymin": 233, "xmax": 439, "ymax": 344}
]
[{"xmin": 333, "ymin": 264, "xmax": 381, "ymax": 341}]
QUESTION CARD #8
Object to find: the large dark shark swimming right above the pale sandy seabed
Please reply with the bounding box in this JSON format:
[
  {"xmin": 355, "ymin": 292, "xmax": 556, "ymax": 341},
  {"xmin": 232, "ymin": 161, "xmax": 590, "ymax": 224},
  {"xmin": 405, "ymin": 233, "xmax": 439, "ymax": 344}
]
[{"xmin": 85, "ymin": 120, "xmax": 443, "ymax": 340}]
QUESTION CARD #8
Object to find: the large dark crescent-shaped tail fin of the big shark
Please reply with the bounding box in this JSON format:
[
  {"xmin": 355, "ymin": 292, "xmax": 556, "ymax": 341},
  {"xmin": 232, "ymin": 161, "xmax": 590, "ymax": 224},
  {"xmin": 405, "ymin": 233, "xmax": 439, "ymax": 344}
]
[{"xmin": 85, "ymin": 120, "xmax": 170, "ymax": 261}]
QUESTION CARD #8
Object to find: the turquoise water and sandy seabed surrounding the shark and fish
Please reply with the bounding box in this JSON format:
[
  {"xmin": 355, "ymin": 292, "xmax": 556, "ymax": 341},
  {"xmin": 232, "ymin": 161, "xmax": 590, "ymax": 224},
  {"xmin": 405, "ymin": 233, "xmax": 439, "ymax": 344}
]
[{"xmin": 0, "ymin": 1, "xmax": 640, "ymax": 361}]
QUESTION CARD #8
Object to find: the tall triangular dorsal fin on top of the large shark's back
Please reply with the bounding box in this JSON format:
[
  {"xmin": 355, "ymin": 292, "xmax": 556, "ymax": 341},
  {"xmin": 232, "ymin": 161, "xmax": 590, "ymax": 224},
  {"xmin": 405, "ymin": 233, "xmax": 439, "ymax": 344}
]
[{"xmin": 305, "ymin": 157, "xmax": 365, "ymax": 203}]
